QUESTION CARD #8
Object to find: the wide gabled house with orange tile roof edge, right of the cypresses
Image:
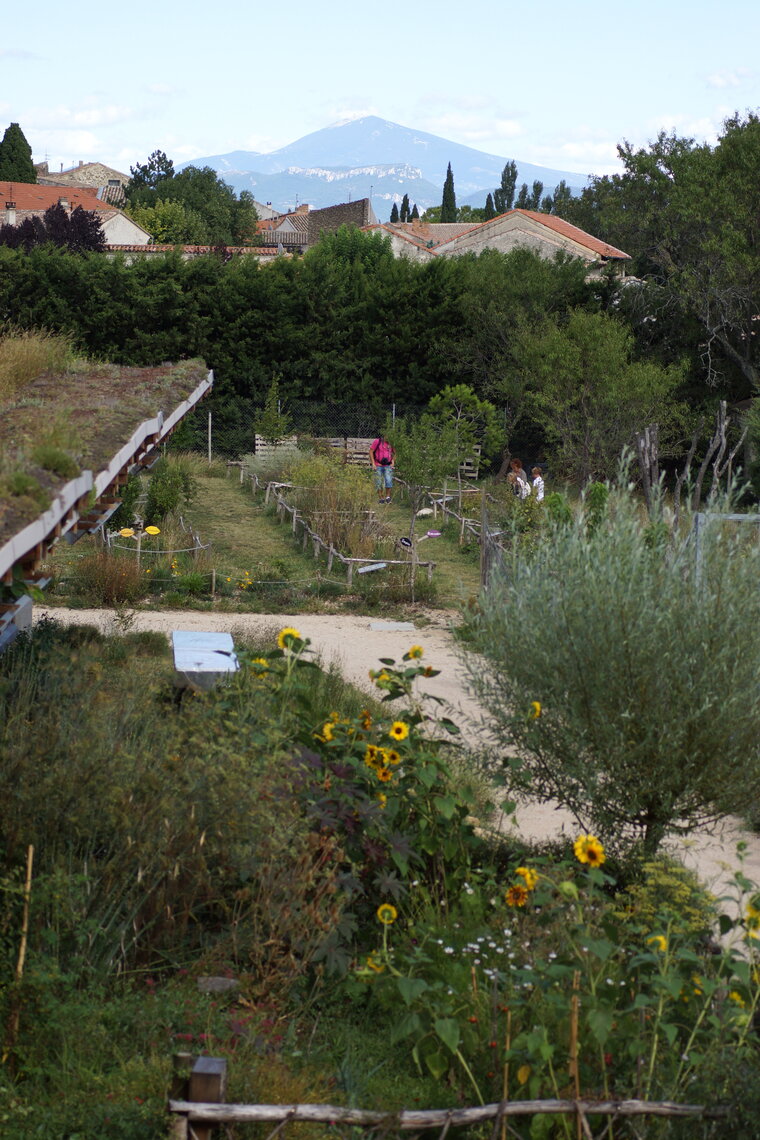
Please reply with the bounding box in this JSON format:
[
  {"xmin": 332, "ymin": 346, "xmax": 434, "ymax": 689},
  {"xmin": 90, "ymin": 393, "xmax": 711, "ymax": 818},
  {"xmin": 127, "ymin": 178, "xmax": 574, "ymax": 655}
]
[{"xmin": 431, "ymin": 210, "xmax": 631, "ymax": 276}]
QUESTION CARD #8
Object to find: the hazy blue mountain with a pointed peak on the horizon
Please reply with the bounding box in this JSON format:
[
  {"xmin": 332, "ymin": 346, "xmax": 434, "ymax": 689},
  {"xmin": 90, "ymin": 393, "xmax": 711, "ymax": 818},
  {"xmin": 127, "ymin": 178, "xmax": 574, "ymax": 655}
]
[{"xmin": 180, "ymin": 115, "xmax": 587, "ymax": 221}]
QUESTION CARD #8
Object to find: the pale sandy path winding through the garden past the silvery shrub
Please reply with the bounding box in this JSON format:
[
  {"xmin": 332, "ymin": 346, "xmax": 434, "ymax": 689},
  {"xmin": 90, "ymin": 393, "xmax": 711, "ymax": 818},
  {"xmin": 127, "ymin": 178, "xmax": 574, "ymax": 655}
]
[{"xmin": 35, "ymin": 606, "xmax": 760, "ymax": 895}]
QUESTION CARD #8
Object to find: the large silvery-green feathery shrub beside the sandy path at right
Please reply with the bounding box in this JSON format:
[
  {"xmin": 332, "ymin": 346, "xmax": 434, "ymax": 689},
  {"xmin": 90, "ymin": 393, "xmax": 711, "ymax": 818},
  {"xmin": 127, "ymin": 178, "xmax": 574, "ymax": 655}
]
[{"xmin": 468, "ymin": 478, "xmax": 760, "ymax": 855}]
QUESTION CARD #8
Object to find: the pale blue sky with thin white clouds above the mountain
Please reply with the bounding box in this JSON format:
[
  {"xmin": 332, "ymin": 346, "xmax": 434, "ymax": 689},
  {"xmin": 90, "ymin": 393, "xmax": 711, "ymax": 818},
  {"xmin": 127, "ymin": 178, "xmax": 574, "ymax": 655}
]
[{"xmin": 0, "ymin": 0, "xmax": 760, "ymax": 174}]
